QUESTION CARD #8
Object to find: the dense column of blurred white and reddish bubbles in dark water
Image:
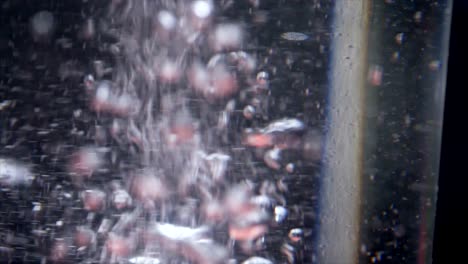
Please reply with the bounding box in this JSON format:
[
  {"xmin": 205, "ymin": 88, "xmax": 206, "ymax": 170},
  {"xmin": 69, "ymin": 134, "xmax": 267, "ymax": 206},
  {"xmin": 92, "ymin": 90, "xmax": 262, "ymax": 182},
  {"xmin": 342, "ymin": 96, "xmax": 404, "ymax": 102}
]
[{"xmin": 0, "ymin": 0, "xmax": 322, "ymax": 264}]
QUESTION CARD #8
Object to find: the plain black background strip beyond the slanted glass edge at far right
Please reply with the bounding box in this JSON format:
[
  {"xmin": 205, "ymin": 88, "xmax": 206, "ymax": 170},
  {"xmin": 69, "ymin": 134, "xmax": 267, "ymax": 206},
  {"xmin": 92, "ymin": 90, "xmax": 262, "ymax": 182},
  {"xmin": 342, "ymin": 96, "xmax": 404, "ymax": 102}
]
[{"xmin": 433, "ymin": 0, "xmax": 468, "ymax": 263}]
